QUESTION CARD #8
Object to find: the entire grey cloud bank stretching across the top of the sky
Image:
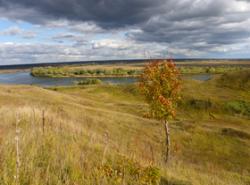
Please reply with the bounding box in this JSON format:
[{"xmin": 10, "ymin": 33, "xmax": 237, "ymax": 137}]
[{"xmin": 0, "ymin": 0, "xmax": 250, "ymax": 60}]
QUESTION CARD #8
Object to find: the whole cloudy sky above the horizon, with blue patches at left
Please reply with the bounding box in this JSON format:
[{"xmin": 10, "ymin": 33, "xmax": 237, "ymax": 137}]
[{"xmin": 0, "ymin": 0, "xmax": 250, "ymax": 65}]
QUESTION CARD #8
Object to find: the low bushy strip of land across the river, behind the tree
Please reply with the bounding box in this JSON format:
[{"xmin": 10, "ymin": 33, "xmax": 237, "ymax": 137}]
[{"xmin": 31, "ymin": 62, "xmax": 247, "ymax": 78}]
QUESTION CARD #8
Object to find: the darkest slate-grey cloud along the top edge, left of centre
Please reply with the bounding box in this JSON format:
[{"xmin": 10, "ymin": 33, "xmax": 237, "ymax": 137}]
[{"xmin": 0, "ymin": 0, "xmax": 166, "ymax": 28}]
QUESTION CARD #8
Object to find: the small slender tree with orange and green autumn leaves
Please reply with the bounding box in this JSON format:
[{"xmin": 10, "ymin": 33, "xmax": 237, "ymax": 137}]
[{"xmin": 139, "ymin": 60, "xmax": 180, "ymax": 162}]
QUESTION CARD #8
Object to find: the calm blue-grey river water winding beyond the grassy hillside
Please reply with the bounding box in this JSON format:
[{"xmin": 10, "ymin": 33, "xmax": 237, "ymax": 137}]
[{"xmin": 0, "ymin": 72, "xmax": 211, "ymax": 86}]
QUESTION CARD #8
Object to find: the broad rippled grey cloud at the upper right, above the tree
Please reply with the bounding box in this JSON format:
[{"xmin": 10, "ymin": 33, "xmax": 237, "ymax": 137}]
[{"xmin": 128, "ymin": 0, "xmax": 250, "ymax": 51}]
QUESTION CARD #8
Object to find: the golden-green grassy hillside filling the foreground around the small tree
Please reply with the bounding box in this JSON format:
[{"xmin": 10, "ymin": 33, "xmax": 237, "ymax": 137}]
[{"xmin": 0, "ymin": 70, "xmax": 250, "ymax": 185}]
